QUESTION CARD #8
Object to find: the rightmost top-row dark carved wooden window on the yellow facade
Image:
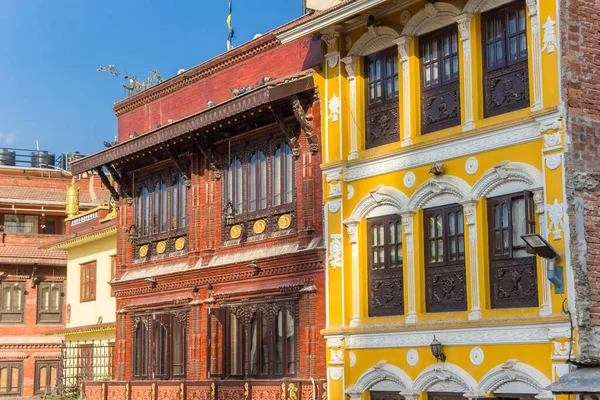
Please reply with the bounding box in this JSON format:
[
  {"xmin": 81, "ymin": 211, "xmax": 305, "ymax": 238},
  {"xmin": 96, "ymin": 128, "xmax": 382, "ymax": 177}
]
[{"xmin": 481, "ymin": 1, "xmax": 529, "ymax": 118}]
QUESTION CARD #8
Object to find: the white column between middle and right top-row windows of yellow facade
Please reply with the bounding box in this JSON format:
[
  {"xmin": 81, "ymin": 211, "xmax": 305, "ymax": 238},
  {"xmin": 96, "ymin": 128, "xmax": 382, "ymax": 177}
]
[{"xmin": 456, "ymin": 13, "xmax": 475, "ymax": 132}]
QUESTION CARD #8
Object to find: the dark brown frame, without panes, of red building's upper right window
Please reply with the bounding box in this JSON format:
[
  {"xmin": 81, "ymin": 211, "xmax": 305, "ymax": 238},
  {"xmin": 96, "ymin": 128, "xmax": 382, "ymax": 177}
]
[{"xmin": 222, "ymin": 135, "xmax": 297, "ymax": 224}]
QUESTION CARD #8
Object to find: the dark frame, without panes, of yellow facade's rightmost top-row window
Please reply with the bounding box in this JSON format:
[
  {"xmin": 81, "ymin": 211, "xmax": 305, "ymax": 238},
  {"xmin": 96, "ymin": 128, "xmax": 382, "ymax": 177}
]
[{"xmin": 481, "ymin": 0, "xmax": 530, "ymax": 118}]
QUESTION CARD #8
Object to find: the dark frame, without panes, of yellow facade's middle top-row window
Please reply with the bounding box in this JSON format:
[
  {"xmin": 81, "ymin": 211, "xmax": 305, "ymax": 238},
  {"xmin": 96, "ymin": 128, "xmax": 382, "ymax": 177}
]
[{"xmin": 419, "ymin": 24, "xmax": 461, "ymax": 134}]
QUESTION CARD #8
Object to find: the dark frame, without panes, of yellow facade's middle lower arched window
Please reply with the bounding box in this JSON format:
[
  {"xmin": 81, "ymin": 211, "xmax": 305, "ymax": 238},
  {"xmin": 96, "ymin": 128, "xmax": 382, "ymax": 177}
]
[{"xmin": 423, "ymin": 204, "xmax": 467, "ymax": 313}]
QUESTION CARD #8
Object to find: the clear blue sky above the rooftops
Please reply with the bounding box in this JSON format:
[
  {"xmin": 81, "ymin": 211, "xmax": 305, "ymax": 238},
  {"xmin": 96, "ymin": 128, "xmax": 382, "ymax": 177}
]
[{"xmin": 0, "ymin": 0, "xmax": 302, "ymax": 160}]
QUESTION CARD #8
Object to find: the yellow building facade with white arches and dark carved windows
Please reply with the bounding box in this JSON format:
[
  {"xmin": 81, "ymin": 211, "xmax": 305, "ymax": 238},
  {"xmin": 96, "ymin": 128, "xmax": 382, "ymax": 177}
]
[{"xmin": 279, "ymin": 0, "xmax": 575, "ymax": 400}]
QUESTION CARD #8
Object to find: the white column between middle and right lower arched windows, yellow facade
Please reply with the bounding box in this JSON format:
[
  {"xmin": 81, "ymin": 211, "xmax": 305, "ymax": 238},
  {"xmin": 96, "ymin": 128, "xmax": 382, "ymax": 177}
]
[{"xmin": 462, "ymin": 200, "xmax": 482, "ymax": 321}]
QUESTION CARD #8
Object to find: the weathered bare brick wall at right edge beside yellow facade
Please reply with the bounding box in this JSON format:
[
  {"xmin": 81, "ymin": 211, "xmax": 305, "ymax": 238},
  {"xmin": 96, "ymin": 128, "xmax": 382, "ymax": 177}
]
[{"xmin": 560, "ymin": 0, "xmax": 600, "ymax": 364}]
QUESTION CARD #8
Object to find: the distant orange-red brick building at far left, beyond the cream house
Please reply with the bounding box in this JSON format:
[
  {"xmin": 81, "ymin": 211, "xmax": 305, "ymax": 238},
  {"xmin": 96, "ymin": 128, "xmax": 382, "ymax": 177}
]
[{"xmin": 0, "ymin": 162, "xmax": 108, "ymax": 397}]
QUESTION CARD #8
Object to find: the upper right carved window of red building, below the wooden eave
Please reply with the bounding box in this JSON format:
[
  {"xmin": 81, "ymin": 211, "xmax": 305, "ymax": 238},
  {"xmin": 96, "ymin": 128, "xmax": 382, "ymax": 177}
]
[{"xmin": 223, "ymin": 139, "xmax": 295, "ymax": 223}]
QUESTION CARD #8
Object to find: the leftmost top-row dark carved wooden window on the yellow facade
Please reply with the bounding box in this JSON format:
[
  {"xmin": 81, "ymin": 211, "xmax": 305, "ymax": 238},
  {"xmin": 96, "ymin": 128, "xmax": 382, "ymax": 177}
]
[{"xmin": 364, "ymin": 47, "xmax": 400, "ymax": 149}]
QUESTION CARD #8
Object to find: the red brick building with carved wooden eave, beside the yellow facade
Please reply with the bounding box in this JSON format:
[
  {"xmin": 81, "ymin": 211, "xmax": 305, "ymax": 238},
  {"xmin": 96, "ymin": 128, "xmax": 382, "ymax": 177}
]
[{"xmin": 73, "ymin": 33, "xmax": 326, "ymax": 400}]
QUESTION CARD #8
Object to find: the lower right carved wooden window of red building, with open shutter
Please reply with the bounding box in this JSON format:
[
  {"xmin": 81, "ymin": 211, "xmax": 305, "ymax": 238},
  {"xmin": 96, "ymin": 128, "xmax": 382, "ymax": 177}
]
[{"xmin": 207, "ymin": 301, "xmax": 298, "ymax": 379}]
